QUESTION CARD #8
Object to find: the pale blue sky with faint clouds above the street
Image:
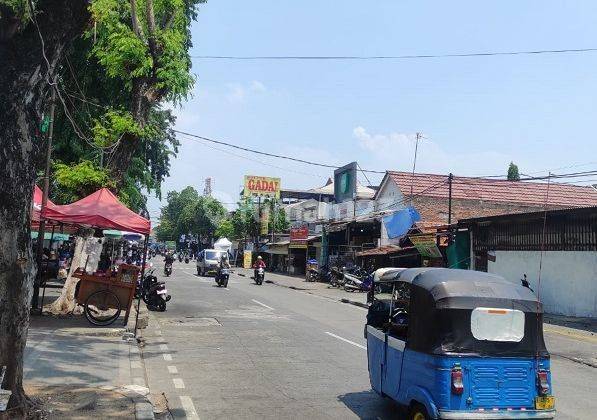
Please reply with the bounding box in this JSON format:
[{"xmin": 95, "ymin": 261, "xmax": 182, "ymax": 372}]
[{"xmin": 149, "ymin": 0, "xmax": 597, "ymax": 220}]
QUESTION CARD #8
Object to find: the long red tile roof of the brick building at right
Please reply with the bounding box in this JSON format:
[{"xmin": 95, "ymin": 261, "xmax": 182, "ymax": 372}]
[{"xmin": 387, "ymin": 171, "xmax": 597, "ymax": 207}]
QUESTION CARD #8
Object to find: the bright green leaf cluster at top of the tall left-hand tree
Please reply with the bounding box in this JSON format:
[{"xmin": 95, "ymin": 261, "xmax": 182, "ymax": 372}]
[{"xmin": 86, "ymin": 0, "xmax": 203, "ymax": 103}]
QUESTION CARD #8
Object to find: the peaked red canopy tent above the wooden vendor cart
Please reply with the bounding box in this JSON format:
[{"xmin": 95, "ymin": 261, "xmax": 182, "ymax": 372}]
[{"xmin": 41, "ymin": 188, "xmax": 151, "ymax": 235}]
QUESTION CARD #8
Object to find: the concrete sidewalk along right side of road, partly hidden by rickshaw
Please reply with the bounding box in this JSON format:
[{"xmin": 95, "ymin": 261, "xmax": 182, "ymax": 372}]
[{"xmin": 243, "ymin": 268, "xmax": 597, "ymax": 368}]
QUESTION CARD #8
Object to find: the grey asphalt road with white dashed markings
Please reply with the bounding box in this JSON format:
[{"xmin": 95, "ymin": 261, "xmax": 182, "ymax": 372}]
[{"xmin": 143, "ymin": 262, "xmax": 597, "ymax": 420}]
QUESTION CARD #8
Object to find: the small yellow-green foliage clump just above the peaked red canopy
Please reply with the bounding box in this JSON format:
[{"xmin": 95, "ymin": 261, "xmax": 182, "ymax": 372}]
[{"xmin": 52, "ymin": 160, "xmax": 114, "ymax": 204}]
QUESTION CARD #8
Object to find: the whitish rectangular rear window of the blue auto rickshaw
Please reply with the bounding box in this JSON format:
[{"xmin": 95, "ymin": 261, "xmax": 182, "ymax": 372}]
[{"xmin": 471, "ymin": 308, "xmax": 524, "ymax": 343}]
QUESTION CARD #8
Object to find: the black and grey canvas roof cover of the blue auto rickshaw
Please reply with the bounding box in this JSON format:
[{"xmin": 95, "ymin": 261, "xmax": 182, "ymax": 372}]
[{"xmin": 386, "ymin": 268, "xmax": 548, "ymax": 357}]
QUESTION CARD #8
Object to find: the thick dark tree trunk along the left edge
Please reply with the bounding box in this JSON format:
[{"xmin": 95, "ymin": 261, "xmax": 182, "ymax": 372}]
[{"xmin": 0, "ymin": 0, "xmax": 89, "ymax": 407}]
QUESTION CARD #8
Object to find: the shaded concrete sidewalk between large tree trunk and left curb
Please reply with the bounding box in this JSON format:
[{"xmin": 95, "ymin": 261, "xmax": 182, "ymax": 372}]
[{"xmin": 24, "ymin": 298, "xmax": 154, "ymax": 419}]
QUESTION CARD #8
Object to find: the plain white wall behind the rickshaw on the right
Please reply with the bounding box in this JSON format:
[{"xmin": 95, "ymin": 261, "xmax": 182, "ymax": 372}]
[{"xmin": 487, "ymin": 251, "xmax": 597, "ymax": 317}]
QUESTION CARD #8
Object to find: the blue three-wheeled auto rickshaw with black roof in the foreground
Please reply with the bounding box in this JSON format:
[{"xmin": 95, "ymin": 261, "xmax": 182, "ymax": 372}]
[{"xmin": 365, "ymin": 268, "xmax": 555, "ymax": 420}]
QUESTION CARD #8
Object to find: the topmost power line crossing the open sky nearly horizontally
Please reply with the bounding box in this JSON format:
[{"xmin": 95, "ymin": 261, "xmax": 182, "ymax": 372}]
[{"xmin": 191, "ymin": 48, "xmax": 597, "ymax": 61}]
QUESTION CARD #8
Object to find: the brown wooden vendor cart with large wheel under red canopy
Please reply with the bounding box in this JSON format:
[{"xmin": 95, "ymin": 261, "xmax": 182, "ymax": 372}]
[{"xmin": 73, "ymin": 264, "xmax": 140, "ymax": 326}]
